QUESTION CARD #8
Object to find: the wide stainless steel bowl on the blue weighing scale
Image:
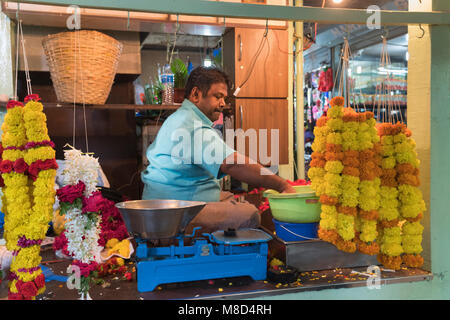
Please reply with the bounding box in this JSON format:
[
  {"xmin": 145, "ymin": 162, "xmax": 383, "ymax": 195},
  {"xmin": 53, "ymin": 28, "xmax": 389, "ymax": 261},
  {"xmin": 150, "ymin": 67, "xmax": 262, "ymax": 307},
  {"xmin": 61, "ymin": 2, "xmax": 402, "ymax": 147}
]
[{"xmin": 116, "ymin": 200, "xmax": 206, "ymax": 239}]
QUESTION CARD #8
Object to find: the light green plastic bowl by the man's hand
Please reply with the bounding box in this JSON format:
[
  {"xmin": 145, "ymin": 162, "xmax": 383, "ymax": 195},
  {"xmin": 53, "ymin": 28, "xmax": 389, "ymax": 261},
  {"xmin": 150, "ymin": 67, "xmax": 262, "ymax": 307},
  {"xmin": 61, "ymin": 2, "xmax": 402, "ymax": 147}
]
[{"xmin": 263, "ymin": 185, "xmax": 320, "ymax": 223}]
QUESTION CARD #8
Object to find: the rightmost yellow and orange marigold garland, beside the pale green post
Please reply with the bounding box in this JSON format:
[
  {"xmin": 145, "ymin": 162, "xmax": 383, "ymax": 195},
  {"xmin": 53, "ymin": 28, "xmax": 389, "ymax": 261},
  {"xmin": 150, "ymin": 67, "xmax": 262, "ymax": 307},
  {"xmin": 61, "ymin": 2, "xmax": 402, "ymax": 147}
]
[{"xmin": 394, "ymin": 125, "xmax": 426, "ymax": 267}]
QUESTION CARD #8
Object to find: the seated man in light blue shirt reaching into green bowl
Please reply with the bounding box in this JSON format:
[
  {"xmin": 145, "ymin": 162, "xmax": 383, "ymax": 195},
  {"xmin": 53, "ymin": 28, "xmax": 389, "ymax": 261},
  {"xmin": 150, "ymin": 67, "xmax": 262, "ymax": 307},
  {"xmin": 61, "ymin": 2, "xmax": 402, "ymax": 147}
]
[{"xmin": 141, "ymin": 67, "xmax": 295, "ymax": 232}]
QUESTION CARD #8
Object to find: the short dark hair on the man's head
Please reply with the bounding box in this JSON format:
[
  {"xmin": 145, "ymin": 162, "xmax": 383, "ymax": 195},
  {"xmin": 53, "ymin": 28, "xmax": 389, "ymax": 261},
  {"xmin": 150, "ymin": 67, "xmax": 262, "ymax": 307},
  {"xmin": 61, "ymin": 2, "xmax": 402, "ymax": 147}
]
[{"xmin": 184, "ymin": 67, "xmax": 232, "ymax": 99}]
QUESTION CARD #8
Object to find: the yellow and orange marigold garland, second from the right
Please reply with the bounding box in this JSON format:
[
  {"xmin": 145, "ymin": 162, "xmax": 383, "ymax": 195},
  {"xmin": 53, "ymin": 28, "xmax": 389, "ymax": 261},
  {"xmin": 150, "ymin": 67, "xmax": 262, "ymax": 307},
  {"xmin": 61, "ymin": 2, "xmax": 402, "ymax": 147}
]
[{"xmin": 377, "ymin": 123, "xmax": 403, "ymax": 270}]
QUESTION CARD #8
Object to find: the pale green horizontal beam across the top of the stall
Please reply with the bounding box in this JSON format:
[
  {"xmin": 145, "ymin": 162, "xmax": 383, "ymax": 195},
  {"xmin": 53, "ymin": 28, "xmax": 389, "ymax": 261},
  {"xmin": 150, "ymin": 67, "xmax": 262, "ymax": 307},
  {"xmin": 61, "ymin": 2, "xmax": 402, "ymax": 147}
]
[{"xmin": 7, "ymin": 0, "xmax": 450, "ymax": 25}]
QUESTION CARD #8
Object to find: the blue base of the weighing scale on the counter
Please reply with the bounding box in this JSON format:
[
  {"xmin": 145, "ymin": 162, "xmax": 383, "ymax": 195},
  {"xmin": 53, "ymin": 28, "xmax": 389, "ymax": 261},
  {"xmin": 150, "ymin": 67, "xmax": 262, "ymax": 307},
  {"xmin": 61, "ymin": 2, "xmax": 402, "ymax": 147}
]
[{"xmin": 136, "ymin": 230, "xmax": 271, "ymax": 292}]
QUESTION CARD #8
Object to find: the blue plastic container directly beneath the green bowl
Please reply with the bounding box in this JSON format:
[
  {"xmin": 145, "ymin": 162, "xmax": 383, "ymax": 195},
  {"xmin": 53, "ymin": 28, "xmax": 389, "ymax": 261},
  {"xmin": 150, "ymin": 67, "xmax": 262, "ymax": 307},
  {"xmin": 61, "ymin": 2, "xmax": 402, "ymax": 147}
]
[{"xmin": 273, "ymin": 219, "xmax": 319, "ymax": 242}]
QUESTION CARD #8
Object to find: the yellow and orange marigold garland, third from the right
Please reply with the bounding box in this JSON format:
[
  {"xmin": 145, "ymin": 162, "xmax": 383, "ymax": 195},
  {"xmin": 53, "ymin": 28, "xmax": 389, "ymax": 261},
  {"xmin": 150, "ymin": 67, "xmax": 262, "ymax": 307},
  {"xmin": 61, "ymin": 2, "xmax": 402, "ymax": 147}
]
[{"xmin": 358, "ymin": 112, "xmax": 381, "ymax": 255}]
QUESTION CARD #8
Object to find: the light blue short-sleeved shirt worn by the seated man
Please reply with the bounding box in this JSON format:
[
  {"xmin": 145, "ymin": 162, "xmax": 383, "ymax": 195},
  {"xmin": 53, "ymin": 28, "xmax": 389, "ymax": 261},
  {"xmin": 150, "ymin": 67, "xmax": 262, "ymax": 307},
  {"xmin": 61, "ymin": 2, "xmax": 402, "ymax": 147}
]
[{"xmin": 141, "ymin": 99, "xmax": 235, "ymax": 202}]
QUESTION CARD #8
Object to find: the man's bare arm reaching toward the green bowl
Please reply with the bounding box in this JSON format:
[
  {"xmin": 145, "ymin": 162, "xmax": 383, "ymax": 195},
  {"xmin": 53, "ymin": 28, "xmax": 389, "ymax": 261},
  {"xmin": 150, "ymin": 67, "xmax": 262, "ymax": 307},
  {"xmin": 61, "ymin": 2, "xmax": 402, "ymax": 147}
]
[{"xmin": 220, "ymin": 152, "xmax": 296, "ymax": 193}]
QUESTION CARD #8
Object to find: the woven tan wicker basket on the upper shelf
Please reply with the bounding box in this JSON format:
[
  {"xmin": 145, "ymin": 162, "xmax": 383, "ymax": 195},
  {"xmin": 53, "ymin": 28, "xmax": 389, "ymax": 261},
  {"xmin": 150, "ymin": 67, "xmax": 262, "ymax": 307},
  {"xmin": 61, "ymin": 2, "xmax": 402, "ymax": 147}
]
[{"xmin": 42, "ymin": 30, "xmax": 123, "ymax": 104}]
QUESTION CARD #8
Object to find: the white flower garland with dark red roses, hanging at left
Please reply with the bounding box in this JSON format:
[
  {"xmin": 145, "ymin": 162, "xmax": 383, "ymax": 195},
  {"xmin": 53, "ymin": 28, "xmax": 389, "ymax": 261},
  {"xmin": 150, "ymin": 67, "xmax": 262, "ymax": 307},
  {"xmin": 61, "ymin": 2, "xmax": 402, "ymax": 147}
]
[{"xmin": 56, "ymin": 148, "xmax": 101, "ymax": 298}]
